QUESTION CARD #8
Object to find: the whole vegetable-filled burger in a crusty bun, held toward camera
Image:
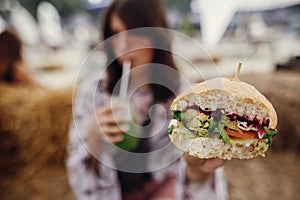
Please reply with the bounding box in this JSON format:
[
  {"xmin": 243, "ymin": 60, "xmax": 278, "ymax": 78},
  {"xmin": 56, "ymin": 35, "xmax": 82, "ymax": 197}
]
[{"xmin": 168, "ymin": 78, "xmax": 277, "ymax": 160}]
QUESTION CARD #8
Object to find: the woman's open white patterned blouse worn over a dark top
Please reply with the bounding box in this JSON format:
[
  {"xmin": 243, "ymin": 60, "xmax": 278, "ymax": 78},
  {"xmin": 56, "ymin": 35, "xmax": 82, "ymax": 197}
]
[{"xmin": 66, "ymin": 76, "xmax": 227, "ymax": 200}]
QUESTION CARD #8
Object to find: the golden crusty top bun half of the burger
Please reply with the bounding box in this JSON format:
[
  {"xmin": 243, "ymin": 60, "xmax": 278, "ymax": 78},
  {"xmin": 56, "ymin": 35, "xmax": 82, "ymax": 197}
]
[{"xmin": 170, "ymin": 78, "xmax": 278, "ymax": 129}]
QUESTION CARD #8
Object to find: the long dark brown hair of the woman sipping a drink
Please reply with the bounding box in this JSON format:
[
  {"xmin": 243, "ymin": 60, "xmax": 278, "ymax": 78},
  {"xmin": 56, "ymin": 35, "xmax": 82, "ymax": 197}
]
[{"xmin": 102, "ymin": 0, "xmax": 179, "ymax": 102}]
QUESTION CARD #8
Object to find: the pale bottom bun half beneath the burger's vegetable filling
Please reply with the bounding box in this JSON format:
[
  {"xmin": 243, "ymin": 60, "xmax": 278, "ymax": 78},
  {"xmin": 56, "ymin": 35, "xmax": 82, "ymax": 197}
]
[{"xmin": 169, "ymin": 129, "xmax": 268, "ymax": 160}]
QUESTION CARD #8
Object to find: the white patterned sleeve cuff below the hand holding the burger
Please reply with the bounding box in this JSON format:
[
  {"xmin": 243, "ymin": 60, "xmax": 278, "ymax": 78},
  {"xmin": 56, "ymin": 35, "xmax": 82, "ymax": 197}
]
[{"xmin": 176, "ymin": 158, "xmax": 228, "ymax": 200}]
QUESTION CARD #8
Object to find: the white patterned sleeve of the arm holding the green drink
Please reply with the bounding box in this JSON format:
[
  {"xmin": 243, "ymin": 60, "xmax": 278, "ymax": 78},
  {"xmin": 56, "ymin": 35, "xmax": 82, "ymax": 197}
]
[{"xmin": 66, "ymin": 80, "xmax": 121, "ymax": 200}]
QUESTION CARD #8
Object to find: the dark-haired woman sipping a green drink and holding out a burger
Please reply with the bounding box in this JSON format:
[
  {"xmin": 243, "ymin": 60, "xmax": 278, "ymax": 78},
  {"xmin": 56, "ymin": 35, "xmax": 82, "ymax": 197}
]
[{"xmin": 67, "ymin": 0, "xmax": 226, "ymax": 199}]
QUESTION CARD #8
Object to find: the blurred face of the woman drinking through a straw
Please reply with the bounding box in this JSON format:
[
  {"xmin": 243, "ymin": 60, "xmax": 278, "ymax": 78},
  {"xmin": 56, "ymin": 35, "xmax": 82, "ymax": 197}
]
[{"xmin": 110, "ymin": 14, "xmax": 154, "ymax": 67}]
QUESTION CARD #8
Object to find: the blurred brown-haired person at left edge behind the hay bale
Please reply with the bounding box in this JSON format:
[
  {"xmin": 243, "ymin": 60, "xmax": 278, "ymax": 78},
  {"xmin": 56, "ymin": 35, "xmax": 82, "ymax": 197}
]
[{"xmin": 0, "ymin": 29, "xmax": 38, "ymax": 86}]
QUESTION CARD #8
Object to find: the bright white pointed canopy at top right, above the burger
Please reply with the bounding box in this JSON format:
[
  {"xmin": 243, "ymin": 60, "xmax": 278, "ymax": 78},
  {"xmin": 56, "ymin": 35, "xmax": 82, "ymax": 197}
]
[{"xmin": 193, "ymin": 0, "xmax": 300, "ymax": 50}]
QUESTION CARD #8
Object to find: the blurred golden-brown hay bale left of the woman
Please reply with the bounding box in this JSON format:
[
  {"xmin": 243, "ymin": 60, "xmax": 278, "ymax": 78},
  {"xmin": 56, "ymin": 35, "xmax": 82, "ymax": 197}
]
[{"xmin": 0, "ymin": 84, "xmax": 73, "ymax": 199}]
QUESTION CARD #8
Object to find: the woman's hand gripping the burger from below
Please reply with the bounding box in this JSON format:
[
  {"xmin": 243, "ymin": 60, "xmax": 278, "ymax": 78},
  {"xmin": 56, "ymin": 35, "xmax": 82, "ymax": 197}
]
[{"xmin": 184, "ymin": 153, "xmax": 225, "ymax": 182}]
